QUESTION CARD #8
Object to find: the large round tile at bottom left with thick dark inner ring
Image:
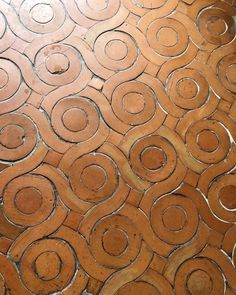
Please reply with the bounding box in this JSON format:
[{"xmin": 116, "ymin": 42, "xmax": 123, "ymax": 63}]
[{"xmin": 20, "ymin": 239, "xmax": 75, "ymax": 295}]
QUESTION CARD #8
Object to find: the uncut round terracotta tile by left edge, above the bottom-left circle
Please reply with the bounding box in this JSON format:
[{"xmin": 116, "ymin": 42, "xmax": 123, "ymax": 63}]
[{"xmin": 3, "ymin": 175, "xmax": 55, "ymax": 226}]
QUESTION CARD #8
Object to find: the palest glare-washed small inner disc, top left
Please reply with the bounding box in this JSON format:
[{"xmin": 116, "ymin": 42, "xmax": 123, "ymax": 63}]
[{"xmin": 31, "ymin": 3, "xmax": 54, "ymax": 24}]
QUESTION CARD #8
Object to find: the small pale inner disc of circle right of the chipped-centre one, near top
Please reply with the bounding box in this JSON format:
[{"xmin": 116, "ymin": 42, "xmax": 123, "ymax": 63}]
[{"xmin": 105, "ymin": 39, "xmax": 128, "ymax": 60}]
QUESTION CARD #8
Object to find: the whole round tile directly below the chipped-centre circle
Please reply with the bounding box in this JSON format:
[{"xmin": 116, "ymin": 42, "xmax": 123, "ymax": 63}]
[{"xmin": 51, "ymin": 97, "xmax": 99, "ymax": 142}]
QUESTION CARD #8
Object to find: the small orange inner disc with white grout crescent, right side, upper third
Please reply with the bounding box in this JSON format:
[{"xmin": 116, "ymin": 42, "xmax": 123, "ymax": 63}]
[{"xmin": 177, "ymin": 78, "xmax": 198, "ymax": 99}]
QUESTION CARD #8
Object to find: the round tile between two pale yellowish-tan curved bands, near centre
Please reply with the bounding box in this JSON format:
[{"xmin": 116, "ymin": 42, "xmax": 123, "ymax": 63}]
[{"xmin": 130, "ymin": 135, "xmax": 176, "ymax": 182}]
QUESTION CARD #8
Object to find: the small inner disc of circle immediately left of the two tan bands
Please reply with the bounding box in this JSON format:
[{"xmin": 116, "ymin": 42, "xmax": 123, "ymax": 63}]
[{"xmin": 81, "ymin": 165, "xmax": 106, "ymax": 191}]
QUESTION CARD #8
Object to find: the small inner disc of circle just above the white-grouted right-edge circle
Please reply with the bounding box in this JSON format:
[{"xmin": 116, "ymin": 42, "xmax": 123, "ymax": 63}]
[{"xmin": 197, "ymin": 130, "xmax": 219, "ymax": 152}]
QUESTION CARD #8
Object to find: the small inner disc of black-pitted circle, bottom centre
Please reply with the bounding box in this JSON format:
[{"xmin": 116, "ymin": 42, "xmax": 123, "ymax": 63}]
[{"xmin": 102, "ymin": 228, "xmax": 128, "ymax": 256}]
